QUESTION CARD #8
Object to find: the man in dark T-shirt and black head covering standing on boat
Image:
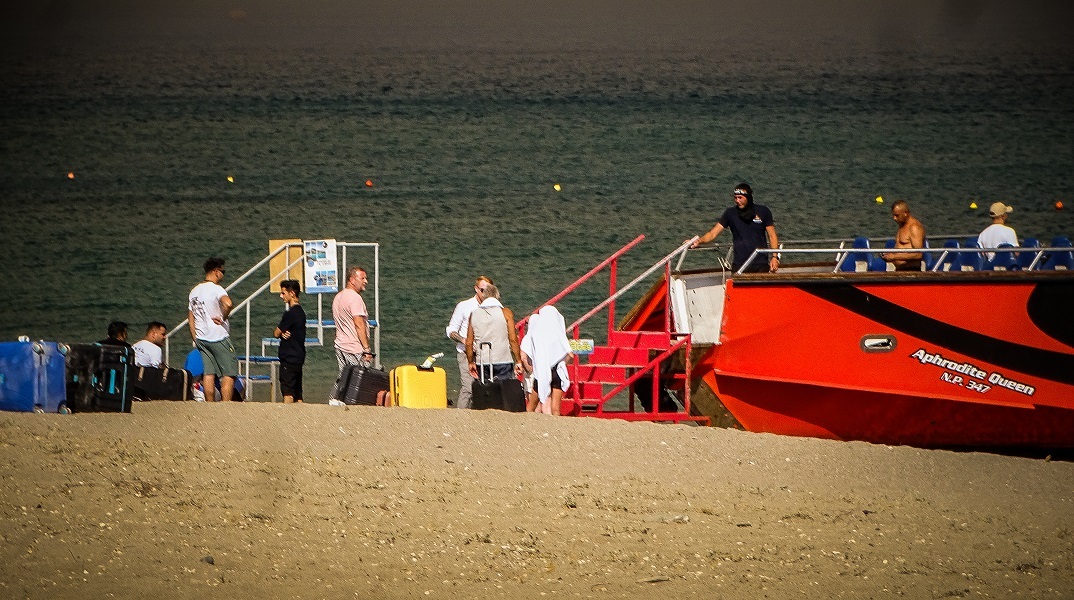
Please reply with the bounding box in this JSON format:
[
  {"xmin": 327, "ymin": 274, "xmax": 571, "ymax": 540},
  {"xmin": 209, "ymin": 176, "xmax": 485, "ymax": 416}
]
[{"xmin": 691, "ymin": 184, "xmax": 780, "ymax": 273}]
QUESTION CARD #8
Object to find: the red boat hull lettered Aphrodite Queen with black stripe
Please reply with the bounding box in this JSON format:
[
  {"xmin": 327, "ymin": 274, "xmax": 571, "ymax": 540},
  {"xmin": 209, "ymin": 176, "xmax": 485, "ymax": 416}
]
[{"xmin": 695, "ymin": 274, "xmax": 1074, "ymax": 449}]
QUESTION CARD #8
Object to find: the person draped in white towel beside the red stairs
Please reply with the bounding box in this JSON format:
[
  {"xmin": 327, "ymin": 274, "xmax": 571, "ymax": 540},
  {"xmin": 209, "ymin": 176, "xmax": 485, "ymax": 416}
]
[{"xmin": 521, "ymin": 305, "xmax": 572, "ymax": 415}]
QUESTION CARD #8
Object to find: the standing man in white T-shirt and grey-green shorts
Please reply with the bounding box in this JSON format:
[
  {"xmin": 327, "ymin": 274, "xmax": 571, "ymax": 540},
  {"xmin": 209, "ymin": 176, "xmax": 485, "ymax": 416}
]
[{"xmin": 187, "ymin": 258, "xmax": 238, "ymax": 403}]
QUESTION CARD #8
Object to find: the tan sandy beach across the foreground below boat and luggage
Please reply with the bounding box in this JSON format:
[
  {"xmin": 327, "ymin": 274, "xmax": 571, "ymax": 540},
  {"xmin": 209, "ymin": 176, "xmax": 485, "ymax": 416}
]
[{"xmin": 0, "ymin": 401, "xmax": 1074, "ymax": 599}]
